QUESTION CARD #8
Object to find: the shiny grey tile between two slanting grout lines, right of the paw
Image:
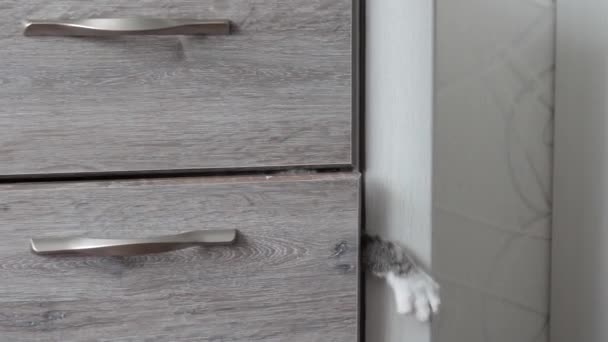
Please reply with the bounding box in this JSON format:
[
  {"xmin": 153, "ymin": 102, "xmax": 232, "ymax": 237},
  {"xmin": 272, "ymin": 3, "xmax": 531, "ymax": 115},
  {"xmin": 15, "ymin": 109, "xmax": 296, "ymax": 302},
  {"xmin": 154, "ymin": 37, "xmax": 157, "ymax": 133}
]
[{"xmin": 433, "ymin": 208, "xmax": 550, "ymax": 313}]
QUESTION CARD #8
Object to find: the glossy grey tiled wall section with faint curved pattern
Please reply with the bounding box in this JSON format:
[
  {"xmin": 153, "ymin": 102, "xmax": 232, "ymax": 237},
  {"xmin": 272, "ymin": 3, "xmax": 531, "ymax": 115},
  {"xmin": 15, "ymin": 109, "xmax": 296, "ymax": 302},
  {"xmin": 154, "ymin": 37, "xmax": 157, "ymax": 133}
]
[{"xmin": 432, "ymin": 0, "xmax": 555, "ymax": 342}]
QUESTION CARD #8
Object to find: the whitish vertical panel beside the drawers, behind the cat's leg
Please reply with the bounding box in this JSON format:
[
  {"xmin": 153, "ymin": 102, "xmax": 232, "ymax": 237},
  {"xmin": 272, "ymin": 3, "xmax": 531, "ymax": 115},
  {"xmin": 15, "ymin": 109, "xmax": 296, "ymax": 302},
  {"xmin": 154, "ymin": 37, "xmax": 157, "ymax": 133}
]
[{"xmin": 364, "ymin": 0, "xmax": 434, "ymax": 342}]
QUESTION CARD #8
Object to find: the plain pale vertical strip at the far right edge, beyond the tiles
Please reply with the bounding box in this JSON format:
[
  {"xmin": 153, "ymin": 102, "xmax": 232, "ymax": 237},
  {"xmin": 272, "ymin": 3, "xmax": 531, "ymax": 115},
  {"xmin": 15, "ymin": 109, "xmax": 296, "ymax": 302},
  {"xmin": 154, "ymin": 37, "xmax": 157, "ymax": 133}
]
[{"xmin": 550, "ymin": 0, "xmax": 608, "ymax": 342}]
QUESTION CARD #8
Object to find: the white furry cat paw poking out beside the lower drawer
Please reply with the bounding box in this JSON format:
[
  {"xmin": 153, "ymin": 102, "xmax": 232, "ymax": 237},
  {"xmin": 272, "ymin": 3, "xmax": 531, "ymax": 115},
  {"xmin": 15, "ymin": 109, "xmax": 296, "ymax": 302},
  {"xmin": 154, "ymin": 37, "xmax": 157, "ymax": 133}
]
[{"xmin": 386, "ymin": 269, "xmax": 441, "ymax": 322}]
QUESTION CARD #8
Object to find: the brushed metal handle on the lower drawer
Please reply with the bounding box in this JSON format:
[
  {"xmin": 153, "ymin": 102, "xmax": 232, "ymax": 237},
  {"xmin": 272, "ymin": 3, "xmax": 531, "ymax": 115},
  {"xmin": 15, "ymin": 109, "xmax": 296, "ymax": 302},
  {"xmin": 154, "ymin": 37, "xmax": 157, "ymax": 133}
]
[{"xmin": 30, "ymin": 229, "xmax": 237, "ymax": 256}]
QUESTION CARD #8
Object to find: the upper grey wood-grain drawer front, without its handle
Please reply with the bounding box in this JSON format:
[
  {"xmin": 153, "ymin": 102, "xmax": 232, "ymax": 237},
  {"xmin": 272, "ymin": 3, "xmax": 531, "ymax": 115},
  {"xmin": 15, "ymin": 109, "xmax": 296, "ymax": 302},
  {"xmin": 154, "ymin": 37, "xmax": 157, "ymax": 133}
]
[{"xmin": 0, "ymin": 0, "xmax": 353, "ymax": 176}]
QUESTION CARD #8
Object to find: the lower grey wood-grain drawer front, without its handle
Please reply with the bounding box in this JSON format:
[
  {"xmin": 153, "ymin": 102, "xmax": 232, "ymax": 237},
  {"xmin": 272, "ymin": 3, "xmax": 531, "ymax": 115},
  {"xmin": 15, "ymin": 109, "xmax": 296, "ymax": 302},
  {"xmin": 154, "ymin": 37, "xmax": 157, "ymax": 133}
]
[{"xmin": 0, "ymin": 174, "xmax": 359, "ymax": 342}]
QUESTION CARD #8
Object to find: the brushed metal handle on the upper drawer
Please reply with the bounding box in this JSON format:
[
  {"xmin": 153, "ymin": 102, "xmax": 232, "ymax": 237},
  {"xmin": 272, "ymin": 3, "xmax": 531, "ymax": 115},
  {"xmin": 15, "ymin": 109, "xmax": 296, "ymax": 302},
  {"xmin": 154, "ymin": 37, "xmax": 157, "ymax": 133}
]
[{"xmin": 23, "ymin": 18, "xmax": 230, "ymax": 37}]
